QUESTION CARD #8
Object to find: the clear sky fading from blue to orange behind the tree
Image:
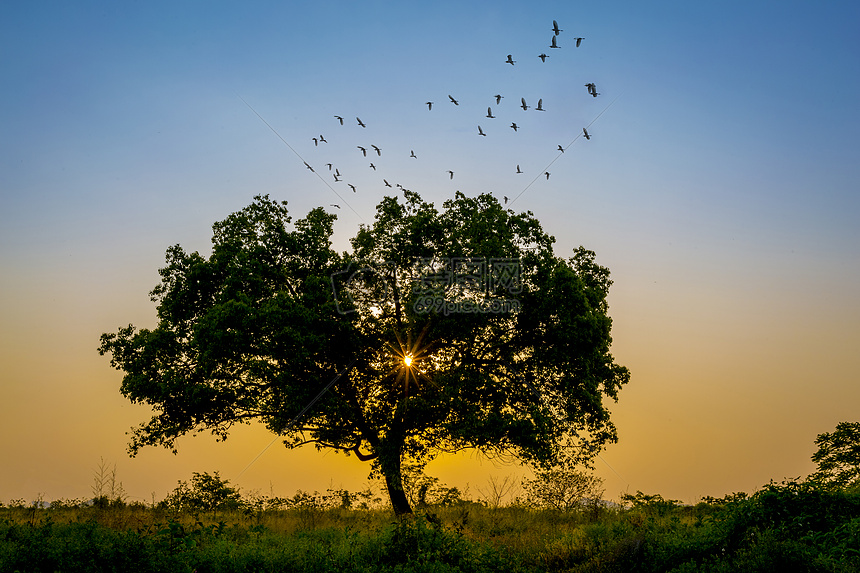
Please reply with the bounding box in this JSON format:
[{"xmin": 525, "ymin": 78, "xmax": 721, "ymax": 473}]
[{"xmin": 0, "ymin": 0, "xmax": 860, "ymax": 503}]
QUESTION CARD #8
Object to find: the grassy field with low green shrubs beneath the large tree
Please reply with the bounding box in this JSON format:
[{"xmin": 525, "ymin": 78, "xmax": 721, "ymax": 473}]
[{"xmin": 0, "ymin": 482, "xmax": 860, "ymax": 573}]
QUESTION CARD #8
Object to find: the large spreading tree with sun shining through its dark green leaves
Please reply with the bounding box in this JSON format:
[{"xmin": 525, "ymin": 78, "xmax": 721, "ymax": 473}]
[{"xmin": 99, "ymin": 192, "xmax": 629, "ymax": 514}]
